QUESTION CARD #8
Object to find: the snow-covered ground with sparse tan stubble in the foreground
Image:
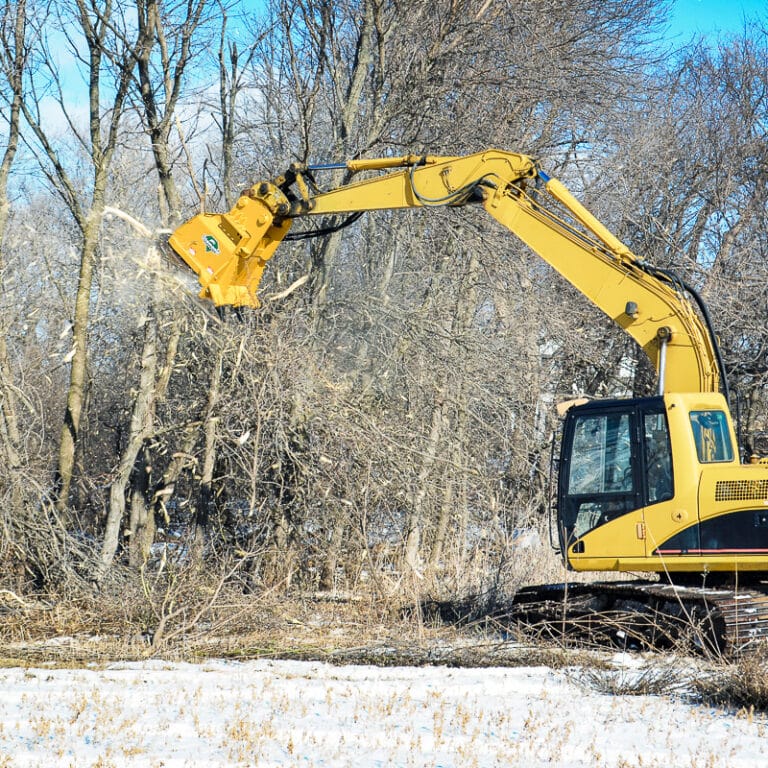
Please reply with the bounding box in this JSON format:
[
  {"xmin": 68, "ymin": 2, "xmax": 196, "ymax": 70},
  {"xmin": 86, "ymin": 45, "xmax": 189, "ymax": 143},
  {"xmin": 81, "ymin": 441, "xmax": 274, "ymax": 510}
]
[{"xmin": 0, "ymin": 660, "xmax": 768, "ymax": 768}]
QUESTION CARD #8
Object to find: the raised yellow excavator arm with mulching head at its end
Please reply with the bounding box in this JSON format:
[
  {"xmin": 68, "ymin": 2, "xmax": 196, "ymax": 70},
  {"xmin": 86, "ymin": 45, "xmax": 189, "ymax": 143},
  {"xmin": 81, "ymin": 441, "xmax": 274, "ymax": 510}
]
[{"xmin": 169, "ymin": 150, "xmax": 727, "ymax": 394}]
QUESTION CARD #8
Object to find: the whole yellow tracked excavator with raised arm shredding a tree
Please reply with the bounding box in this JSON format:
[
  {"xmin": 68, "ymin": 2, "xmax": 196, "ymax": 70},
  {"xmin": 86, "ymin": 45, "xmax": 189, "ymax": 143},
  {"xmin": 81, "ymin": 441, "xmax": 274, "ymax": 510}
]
[{"xmin": 169, "ymin": 150, "xmax": 768, "ymax": 647}]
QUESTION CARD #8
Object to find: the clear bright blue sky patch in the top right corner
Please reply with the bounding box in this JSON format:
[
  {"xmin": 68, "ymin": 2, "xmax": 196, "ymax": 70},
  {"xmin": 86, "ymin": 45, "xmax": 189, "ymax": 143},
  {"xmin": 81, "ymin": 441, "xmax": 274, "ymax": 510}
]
[{"xmin": 669, "ymin": 0, "xmax": 768, "ymax": 42}]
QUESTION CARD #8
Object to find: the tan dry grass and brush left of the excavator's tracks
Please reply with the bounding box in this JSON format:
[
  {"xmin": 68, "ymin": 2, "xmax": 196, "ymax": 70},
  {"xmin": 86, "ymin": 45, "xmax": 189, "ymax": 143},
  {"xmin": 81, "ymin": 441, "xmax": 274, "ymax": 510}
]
[{"xmin": 0, "ymin": 540, "xmax": 616, "ymax": 668}]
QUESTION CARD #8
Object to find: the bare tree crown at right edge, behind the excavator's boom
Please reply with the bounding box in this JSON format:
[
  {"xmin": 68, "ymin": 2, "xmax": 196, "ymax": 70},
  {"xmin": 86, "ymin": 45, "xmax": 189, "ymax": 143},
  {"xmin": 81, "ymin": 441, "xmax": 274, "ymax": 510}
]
[{"xmin": 607, "ymin": 29, "xmax": 768, "ymax": 450}]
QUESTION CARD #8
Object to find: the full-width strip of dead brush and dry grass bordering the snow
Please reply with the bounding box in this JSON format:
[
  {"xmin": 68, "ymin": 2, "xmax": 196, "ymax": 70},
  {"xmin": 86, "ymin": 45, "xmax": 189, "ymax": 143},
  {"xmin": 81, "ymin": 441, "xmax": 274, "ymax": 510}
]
[{"xmin": 0, "ymin": 536, "xmax": 768, "ymax": 713}]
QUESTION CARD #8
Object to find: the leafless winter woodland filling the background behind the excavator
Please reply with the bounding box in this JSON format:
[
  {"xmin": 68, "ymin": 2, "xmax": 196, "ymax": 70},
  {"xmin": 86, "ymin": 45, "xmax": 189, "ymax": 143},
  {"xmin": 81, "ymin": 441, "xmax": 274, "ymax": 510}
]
[{"xmin": 0, "ymin": 0, "xmax": 768, "ymax": 640}]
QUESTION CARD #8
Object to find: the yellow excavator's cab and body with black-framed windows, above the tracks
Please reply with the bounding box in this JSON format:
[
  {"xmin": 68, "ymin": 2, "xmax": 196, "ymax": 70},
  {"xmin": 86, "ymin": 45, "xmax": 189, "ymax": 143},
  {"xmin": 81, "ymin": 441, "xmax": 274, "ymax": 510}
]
[{"xmin": 557, "ymin": 393, "xmax": 768, "ymax": 573}]
